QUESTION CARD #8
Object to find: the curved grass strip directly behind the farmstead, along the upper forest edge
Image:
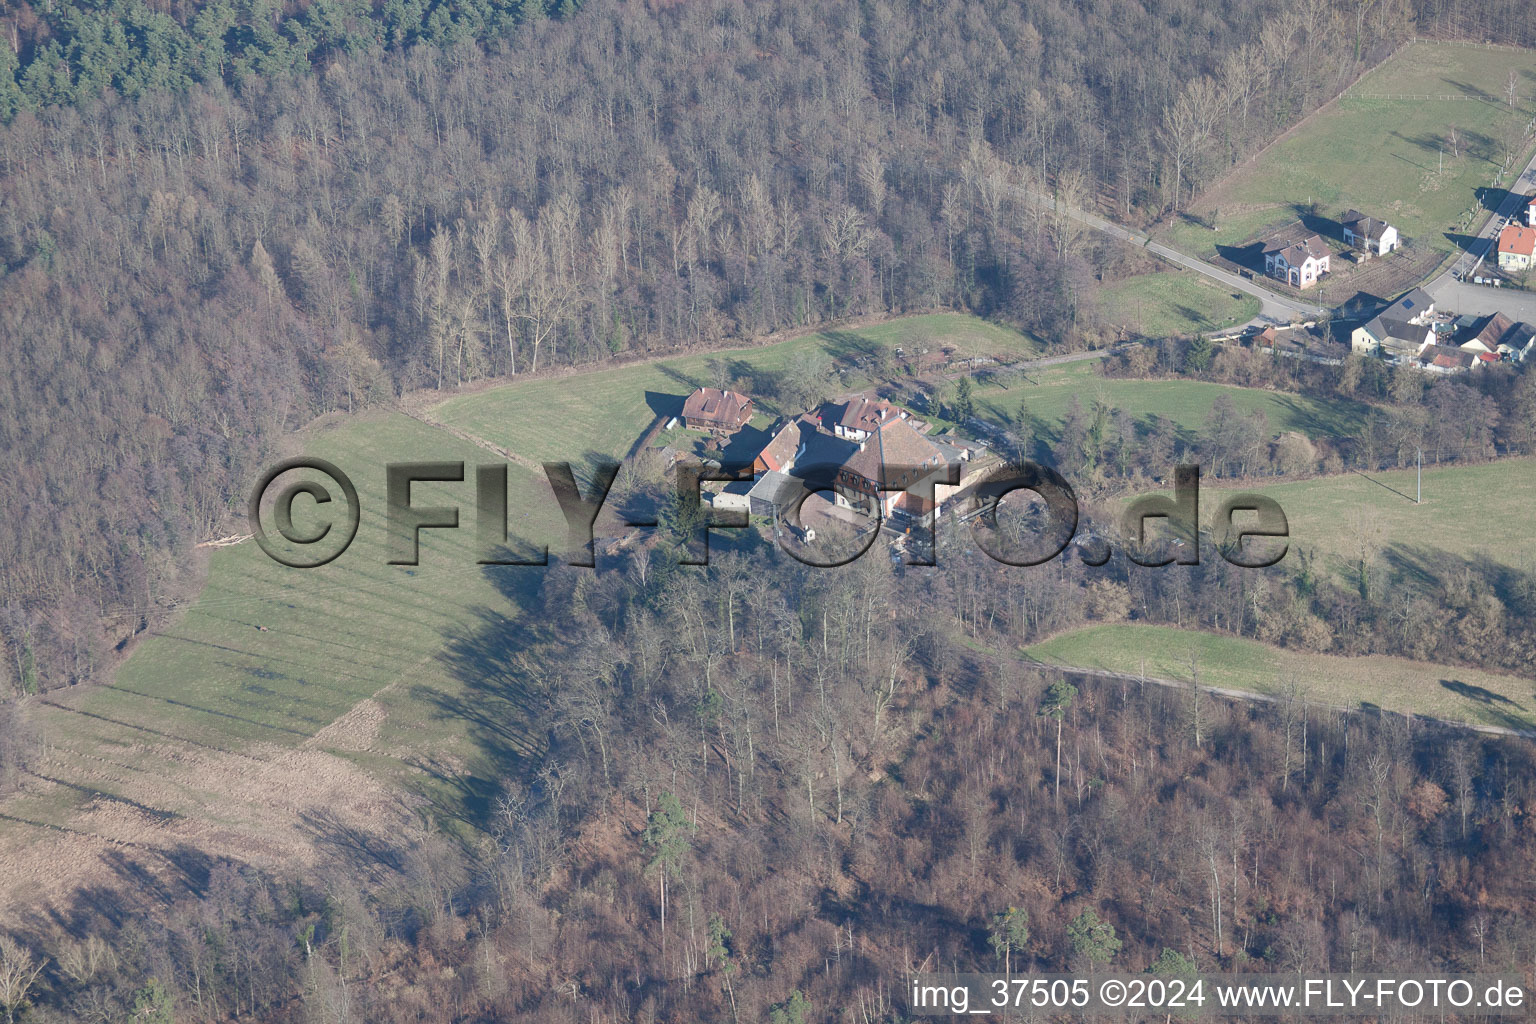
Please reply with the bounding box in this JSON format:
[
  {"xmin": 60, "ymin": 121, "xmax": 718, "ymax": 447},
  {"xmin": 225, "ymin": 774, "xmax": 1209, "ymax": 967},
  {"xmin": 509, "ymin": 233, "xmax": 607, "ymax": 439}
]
[{"xmin": 435, "ymin": 313, "xmax": 1037, "ymax": 461}]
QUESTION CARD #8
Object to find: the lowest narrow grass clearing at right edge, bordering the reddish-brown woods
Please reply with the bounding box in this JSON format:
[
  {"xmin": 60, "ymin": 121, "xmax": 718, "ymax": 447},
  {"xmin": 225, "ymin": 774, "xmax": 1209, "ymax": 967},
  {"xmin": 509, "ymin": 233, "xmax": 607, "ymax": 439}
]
[{"xmin": 1025, "ymin": 625, "xmax": 1536, "ymax": 728}]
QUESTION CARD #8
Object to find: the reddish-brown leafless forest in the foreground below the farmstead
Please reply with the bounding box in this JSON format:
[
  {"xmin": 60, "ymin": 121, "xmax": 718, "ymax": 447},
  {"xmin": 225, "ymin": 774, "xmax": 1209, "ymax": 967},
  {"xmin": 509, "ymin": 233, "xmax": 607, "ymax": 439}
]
[{"xmin": 12, "ymin": 548, "xmax": 1536, "ymax": 1024}]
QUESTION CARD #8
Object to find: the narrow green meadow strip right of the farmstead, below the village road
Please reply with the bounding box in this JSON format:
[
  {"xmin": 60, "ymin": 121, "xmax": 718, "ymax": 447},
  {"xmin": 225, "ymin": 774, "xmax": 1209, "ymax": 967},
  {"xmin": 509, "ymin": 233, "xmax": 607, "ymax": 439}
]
[{"xmin": 975, "ymin": 362, "xmax": 1366, "ymax": 439}]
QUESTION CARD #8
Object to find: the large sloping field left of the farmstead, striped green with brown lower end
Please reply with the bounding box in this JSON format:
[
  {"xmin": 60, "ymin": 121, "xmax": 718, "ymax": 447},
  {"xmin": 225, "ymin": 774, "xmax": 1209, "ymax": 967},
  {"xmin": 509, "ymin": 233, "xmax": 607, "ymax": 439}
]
[{"xmin": 0, "ymin": 415, "xmax": 571, "ymax": 906}]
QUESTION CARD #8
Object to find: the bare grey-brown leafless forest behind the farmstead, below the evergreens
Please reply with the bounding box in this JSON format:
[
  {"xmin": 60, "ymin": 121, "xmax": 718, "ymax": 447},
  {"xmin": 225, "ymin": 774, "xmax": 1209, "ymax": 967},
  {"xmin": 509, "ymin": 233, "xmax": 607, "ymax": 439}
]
[{"xmin": 0, "ymin": 0, "xmax": 1410, "ymax": 691}]
